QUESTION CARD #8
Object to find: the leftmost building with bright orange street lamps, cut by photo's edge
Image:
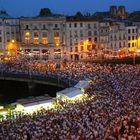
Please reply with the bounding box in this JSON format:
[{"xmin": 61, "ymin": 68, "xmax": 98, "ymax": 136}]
[{"xmin": 0, "ymin": 11, "xmax": 20, "ymax": 55}]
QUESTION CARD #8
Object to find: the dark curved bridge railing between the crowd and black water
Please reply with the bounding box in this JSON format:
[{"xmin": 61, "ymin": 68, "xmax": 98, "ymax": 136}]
[{"xmin": 0, "ymin": 71, "xmax": 77, "ymax": 87}]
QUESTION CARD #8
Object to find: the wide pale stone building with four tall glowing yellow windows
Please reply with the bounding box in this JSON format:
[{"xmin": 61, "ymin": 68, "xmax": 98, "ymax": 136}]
[{"xmin": 20, "ymin": 17, "xmax": 66, "ymax": 59}]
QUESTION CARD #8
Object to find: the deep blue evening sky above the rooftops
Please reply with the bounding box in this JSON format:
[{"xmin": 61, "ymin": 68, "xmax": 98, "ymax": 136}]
[{"xmin": 0, "ymin": 0, "xmax": 140, "ymax": 17}]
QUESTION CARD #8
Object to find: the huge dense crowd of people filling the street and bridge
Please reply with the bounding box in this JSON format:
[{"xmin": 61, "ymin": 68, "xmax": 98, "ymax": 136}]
[{"xmin": 0, "ymin": 60, "xmax": 140, "ymax": 140}]
